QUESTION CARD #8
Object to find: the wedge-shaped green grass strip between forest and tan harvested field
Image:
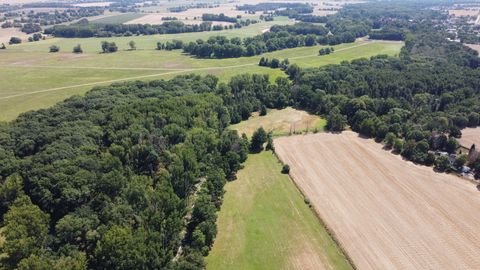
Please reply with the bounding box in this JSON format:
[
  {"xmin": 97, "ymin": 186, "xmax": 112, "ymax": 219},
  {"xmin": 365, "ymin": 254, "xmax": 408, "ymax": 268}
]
[{"xmin": 206, "ymin": 152, "xmax": 351, "ymax": 270}]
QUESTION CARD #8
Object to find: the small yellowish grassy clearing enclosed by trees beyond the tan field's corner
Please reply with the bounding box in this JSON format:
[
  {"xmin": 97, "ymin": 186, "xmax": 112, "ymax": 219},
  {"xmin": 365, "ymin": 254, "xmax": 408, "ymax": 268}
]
[{"xmin": 231, "ymin": 107, "xmax": 327, "ymax": 137}]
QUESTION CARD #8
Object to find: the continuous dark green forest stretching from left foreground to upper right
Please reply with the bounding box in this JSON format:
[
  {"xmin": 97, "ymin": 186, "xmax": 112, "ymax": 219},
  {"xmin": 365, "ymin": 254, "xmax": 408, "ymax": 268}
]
[{"xmin": 0, "ymin": 3, "xmax": 480, "ymax": 269}]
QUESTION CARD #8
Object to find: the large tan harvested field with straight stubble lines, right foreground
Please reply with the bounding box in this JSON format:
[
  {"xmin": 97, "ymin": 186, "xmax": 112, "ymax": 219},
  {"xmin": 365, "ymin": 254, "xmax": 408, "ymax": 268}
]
[{"xmin": 275, "ymin": 132, "xmax": 480, "ymax": 269}]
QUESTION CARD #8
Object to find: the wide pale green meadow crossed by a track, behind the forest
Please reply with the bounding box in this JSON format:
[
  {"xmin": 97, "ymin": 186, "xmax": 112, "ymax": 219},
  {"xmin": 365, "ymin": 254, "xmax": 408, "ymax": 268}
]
[{"xmin": 0, "ymin": 30, "xmax": 402, "ymax": 121}]
